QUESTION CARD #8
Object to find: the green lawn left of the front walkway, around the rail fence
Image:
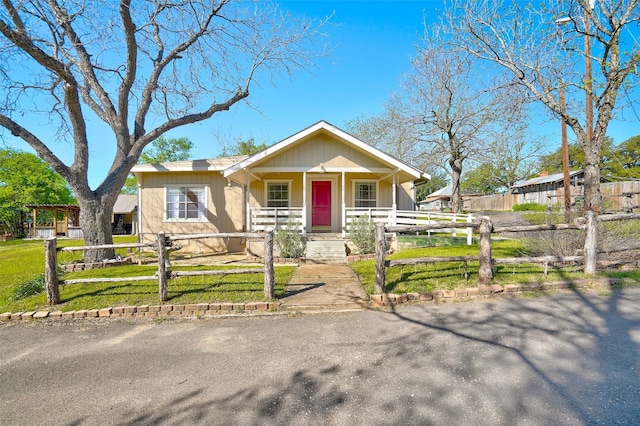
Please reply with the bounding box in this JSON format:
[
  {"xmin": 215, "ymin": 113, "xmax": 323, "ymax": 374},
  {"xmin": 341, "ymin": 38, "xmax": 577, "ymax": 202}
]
[{"xmin": 0, "ymin": 237, "xmax": 295, "ymax": 313}]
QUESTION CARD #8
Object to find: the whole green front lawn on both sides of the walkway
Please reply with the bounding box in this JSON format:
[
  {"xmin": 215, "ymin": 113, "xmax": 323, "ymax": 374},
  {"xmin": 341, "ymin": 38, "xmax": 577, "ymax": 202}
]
[{"xmin": 0, "ymin": 237, "xmax": 640, "ymax": 313}]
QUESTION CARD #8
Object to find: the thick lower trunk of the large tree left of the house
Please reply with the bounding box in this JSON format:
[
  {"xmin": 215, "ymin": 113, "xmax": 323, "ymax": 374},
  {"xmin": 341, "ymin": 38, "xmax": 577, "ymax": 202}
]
[{"xmin": 78, "ymin": 194, "xmax": 117, "ymax": 263}]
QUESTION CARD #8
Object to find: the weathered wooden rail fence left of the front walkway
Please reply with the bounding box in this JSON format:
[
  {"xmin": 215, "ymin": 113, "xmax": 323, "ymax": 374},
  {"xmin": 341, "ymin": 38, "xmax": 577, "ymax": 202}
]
[{"xmin": 44, "ymin": 230, "xmax": 275, "ymax": 305}]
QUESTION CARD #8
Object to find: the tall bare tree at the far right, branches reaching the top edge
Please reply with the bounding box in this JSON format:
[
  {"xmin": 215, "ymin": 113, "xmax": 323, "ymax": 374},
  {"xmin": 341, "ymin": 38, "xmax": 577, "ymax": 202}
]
[{"xmin": 442, "ymin": 0, "xmax": 640, "ymax": 212}]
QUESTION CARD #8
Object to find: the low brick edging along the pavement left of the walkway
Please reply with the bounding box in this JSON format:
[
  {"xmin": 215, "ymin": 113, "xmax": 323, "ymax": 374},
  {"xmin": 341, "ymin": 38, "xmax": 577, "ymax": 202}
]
[{"xmin": 0, "ymin": 302, "xmax": 281, "ymax": 321}]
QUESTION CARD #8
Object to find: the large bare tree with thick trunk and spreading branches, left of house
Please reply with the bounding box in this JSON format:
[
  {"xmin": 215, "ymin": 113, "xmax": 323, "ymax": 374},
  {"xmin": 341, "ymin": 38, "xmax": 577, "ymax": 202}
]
[{"xmin": 0, "ymin": 0, "xmax": 322, "ymax": 260}]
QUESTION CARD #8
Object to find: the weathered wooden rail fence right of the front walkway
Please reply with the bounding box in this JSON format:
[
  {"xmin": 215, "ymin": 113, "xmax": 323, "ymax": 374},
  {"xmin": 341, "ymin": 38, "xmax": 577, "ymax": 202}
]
[{"xmin": 374, "ymin": 212, "xmax": 640, "ymax": 294}]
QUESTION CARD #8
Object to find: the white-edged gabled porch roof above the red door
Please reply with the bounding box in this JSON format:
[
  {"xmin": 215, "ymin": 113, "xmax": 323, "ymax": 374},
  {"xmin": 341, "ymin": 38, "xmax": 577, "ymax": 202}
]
[{"xmin": 223, "ymin": 121, "xmax": 431, "ymax": 185}]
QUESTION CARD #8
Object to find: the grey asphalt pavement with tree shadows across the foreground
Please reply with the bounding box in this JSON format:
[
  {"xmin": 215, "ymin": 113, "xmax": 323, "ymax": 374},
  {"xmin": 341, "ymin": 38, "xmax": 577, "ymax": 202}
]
[{"xmin": 0, "ymin": 288, "xmax": 640, "ymax": 425}]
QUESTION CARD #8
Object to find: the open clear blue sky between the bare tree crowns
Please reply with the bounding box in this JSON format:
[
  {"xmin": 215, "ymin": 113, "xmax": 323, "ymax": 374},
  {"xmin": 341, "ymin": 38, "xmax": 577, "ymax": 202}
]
[{"xmin": 4, "ymin": 0, "xmax": 640, "ymax": 187}]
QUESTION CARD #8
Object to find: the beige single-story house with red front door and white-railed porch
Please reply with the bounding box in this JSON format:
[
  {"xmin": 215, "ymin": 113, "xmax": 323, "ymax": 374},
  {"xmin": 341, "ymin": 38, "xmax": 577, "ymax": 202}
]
[{"xmin": 132, "ymin": 121, "xmax": 430, "ymax": 251}]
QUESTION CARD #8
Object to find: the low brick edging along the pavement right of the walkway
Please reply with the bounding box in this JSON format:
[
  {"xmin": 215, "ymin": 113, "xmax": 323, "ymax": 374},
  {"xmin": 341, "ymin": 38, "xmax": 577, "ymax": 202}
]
[{"xmin": 369, "ymin": 278, "xmax": 622, "ymax": 308}]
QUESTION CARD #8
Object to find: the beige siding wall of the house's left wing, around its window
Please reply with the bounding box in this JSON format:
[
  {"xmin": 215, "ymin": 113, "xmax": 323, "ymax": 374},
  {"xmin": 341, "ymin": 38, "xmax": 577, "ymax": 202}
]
[{"xmin": 140, "ymin": 172, "xmax": 244, "ymax": 252}]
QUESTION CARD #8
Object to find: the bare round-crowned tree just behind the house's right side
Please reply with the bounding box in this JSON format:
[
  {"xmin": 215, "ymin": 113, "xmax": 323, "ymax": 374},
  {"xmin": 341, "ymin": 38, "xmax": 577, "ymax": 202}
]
[{"xmin": 388, "ymin": 41, "xmax": 523, "ymax": 211}]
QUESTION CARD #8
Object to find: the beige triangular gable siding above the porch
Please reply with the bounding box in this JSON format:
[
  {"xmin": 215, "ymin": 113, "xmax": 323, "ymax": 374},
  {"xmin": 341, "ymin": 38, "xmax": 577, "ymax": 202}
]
[{"xmin": 255, "ymin": 133, "xmax": 381, "ymax": 168}]
